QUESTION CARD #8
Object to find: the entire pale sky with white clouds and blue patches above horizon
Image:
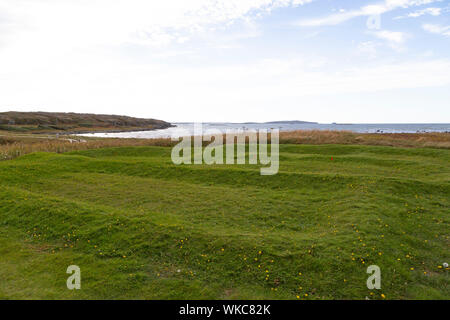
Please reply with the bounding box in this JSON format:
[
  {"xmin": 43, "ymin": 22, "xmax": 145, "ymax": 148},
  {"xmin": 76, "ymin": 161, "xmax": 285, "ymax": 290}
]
[{"xmin": 0, "ymin": 0, "xmax": 450, "ymax": 123}]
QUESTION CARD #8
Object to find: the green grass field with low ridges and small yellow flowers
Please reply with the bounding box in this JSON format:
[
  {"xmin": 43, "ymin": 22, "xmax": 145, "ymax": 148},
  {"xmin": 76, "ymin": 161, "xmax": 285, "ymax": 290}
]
[{"xmin": 0, "ymin": 145, "xmax": 450, "ymax": 299}]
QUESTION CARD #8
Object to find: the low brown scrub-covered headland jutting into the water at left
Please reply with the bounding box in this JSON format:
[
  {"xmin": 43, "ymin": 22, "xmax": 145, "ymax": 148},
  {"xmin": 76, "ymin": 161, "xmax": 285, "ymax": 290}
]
[{"xmin": 0, "ymin": 111, "xmax": 173, "ymax": 134}]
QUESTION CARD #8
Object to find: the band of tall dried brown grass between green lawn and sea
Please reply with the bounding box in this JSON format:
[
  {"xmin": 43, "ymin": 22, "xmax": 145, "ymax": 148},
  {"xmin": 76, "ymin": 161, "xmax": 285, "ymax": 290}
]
[{"xmin": 0, "ymin": 130, "xmax": 450, "ymax": 160}]
